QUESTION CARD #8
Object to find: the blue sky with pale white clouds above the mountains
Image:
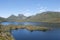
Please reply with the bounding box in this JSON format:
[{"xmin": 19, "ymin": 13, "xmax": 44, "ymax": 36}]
[{"xmin": 0, "ymin": 0, "xmax": 60, "ymax": 18}]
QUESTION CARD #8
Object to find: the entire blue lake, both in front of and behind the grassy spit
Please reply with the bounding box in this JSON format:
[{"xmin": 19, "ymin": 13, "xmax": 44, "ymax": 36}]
[{"xmin": 2, "ymin": 22, "xmax": 60, "ymax": 40}]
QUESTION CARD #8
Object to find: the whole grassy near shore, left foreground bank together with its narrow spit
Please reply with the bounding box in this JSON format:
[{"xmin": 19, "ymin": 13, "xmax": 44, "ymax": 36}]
[{"xmin": 0, "ymin": 25, "xmax": 51, "ymax": 40}]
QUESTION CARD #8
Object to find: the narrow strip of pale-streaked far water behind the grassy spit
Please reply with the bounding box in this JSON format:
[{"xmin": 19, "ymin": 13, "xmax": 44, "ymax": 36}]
[{"xmin": 2, "ymin": 22, "xmax": 60, "ymax": 27}]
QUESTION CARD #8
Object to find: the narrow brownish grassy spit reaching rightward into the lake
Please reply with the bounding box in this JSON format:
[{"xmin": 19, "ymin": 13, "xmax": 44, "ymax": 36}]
[{"xmin": 2, "ymin": 25, "xmax": 51, "ymax": 31}]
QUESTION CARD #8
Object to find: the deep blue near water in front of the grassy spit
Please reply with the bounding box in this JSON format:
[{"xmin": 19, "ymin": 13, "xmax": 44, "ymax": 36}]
[{"xmin": 12, "ymin": 29, "xmax": 60, "ymax": 40}]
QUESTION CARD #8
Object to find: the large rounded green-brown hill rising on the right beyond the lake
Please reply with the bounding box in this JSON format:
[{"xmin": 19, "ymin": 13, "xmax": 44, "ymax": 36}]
[{"xmin": 27, "ymin": 11, "xmax": 60, "ymax": 22}]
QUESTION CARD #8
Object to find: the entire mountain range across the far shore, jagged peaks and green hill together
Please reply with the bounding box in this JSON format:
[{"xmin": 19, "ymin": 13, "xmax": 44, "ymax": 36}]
[{"xmin": 0, "ymin": 11, "xmax": 60, "ymax": 22}]
